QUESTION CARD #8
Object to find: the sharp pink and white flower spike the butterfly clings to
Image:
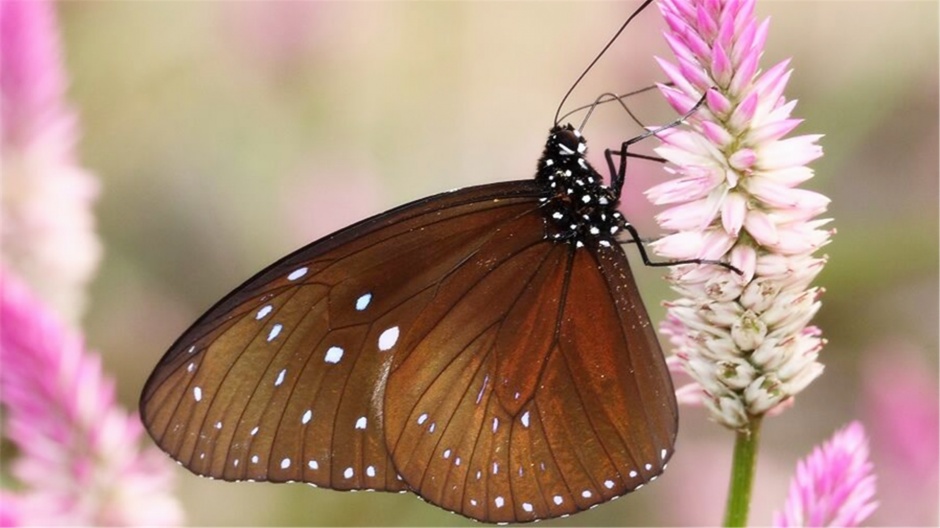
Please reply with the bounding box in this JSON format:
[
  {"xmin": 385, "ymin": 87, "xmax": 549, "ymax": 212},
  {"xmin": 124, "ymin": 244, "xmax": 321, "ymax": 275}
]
[{"xmin": 646, "ymin": 0, "xmax": 831, "ymax": 429}]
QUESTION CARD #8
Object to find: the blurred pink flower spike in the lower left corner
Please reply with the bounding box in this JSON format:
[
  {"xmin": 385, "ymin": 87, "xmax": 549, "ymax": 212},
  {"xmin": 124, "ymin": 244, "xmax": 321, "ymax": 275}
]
[{"xmin": 0, "ymin": 270, "xmax": 182, "ymax": 525}]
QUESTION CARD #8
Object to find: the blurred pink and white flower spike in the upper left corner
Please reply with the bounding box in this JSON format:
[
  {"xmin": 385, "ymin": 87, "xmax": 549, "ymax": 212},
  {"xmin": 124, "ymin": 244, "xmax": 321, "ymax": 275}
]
[{"xmin": 0, "ymin": 0, "xmax": 101, "ymax": 324}]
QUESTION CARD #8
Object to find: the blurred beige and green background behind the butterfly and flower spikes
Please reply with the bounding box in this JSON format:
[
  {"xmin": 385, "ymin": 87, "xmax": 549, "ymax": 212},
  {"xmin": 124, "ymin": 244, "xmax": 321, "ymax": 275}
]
[{"xmin": 46, "ymin": 1, "xmax": 940, "ymax": 526}]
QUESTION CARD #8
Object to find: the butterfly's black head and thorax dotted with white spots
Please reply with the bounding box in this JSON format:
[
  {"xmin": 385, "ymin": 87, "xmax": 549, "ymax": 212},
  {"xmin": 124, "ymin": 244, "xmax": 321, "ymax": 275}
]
[{"xmin": 535, "ymin": 124, "xmax": 625, "ymax": 248}]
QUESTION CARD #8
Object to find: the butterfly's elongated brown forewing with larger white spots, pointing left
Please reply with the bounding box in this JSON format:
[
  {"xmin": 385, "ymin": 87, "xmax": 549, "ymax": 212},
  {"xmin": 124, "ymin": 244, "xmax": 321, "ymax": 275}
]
[{"xmin": 141, "ymin": 182, "xmax": 541, "ymax": 490}]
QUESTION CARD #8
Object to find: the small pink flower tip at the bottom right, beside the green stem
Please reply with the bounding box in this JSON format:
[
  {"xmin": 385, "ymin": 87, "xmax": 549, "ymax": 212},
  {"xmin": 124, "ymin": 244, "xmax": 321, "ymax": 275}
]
[{"xmin": 774, "ymin": 422, "xmax": 878, "ymax": 527}]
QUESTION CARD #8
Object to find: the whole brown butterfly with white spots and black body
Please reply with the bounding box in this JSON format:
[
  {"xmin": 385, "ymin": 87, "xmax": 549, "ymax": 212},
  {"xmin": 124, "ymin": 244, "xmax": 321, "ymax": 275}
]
[{"xmin": 140, "ymin": 0, "xmax": 696, "ymax": 522}]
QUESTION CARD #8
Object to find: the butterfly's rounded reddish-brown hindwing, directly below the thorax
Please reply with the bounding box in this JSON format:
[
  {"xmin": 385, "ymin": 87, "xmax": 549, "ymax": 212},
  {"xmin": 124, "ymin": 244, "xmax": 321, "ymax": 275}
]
[{"xmin": 385, "ymin": 243, "xmax": 677, "ymax": 522}]
